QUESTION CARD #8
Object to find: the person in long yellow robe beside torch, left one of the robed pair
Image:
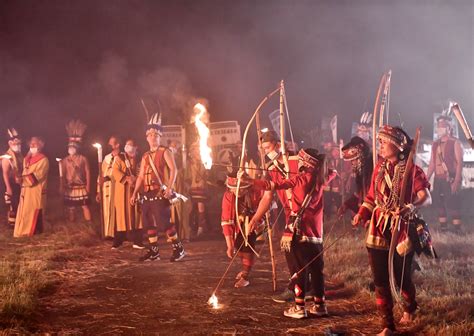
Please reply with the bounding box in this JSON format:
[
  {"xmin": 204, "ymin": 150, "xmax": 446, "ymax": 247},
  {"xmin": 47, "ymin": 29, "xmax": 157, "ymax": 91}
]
[{"xmin": 96, "ymin": 135, "xmax": 120, "ymax": 238}]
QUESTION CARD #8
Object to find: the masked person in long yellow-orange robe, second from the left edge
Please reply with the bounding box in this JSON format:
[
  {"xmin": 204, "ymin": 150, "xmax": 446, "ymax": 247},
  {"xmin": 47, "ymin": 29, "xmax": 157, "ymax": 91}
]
[{"xmin": 13, "ymin": 137, "xmax": 49, "ymax": 237}]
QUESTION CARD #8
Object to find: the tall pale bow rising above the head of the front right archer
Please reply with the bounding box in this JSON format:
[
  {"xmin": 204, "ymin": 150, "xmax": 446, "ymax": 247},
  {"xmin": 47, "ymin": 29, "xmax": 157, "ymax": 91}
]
[{"xmin": 372, "ymin": 70, "xmax": 392, "ymax": 167}]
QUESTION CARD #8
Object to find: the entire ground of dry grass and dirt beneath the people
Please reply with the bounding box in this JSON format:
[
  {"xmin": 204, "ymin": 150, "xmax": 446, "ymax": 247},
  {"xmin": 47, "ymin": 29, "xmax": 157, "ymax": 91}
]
[{"xmin": 0, "ymin": 185, "xmax": 474, "ymax": 335}]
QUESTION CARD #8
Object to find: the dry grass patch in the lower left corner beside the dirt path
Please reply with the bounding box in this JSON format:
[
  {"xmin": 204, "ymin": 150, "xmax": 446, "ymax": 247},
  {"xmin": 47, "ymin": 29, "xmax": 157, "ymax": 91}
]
[{"xmin": 0, "ymin": 217, "xmax": 99, "ymax": 335}]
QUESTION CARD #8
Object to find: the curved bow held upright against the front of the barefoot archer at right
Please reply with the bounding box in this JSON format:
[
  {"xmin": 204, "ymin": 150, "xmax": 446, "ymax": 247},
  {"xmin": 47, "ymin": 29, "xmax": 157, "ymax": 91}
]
[{"xmin": 388, "ymin": 127, "xmax": 421, "ymax": 302}]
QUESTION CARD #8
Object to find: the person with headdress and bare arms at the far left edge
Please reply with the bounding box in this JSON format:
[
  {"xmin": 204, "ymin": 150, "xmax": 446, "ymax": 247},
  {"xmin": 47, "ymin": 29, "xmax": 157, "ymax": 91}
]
[{"xmin": 2, "ymin": 128, "xmax": 23, "ymax": 227}]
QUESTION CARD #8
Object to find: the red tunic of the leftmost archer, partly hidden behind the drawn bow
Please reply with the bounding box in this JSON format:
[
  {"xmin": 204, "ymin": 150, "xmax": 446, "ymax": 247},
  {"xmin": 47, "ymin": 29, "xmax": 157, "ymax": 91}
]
[{"xmin": 221, "ymin": 188, "xmax": 262, "ymax": 237}]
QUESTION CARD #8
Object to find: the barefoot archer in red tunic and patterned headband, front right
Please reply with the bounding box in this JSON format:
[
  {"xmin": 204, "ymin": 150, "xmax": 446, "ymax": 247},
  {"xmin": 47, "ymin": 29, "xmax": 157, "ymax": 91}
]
[{"xmin": 352, "ymin": 125, "xmax": 431, "ymax": 335}]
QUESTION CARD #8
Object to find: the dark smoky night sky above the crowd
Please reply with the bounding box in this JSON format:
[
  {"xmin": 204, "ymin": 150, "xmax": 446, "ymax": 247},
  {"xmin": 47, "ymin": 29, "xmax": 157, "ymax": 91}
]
[{"xmin": 0, "ymin": 0, "xmax": 474, "ymax": 152}]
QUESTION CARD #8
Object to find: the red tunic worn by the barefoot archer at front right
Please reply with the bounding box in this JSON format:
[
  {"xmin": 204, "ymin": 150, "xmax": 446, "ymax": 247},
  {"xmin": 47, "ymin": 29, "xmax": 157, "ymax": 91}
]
[{"xmin": 358, "ymin": 160, "xmax": 430, "ymax": 250}]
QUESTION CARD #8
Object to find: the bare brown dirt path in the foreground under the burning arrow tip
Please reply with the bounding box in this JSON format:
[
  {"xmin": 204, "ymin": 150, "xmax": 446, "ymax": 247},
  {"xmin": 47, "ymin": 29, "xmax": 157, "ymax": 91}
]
[{"xmin": 33, "ymin": 236, "xmax": 396, "ymax": 335}]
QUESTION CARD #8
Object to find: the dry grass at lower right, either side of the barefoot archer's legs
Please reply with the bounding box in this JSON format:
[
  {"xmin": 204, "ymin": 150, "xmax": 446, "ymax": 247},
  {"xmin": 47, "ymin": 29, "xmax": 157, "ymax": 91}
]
[{"xmin": 325, "ymin": 218, "xmax": 474, "ymax": 335}]
